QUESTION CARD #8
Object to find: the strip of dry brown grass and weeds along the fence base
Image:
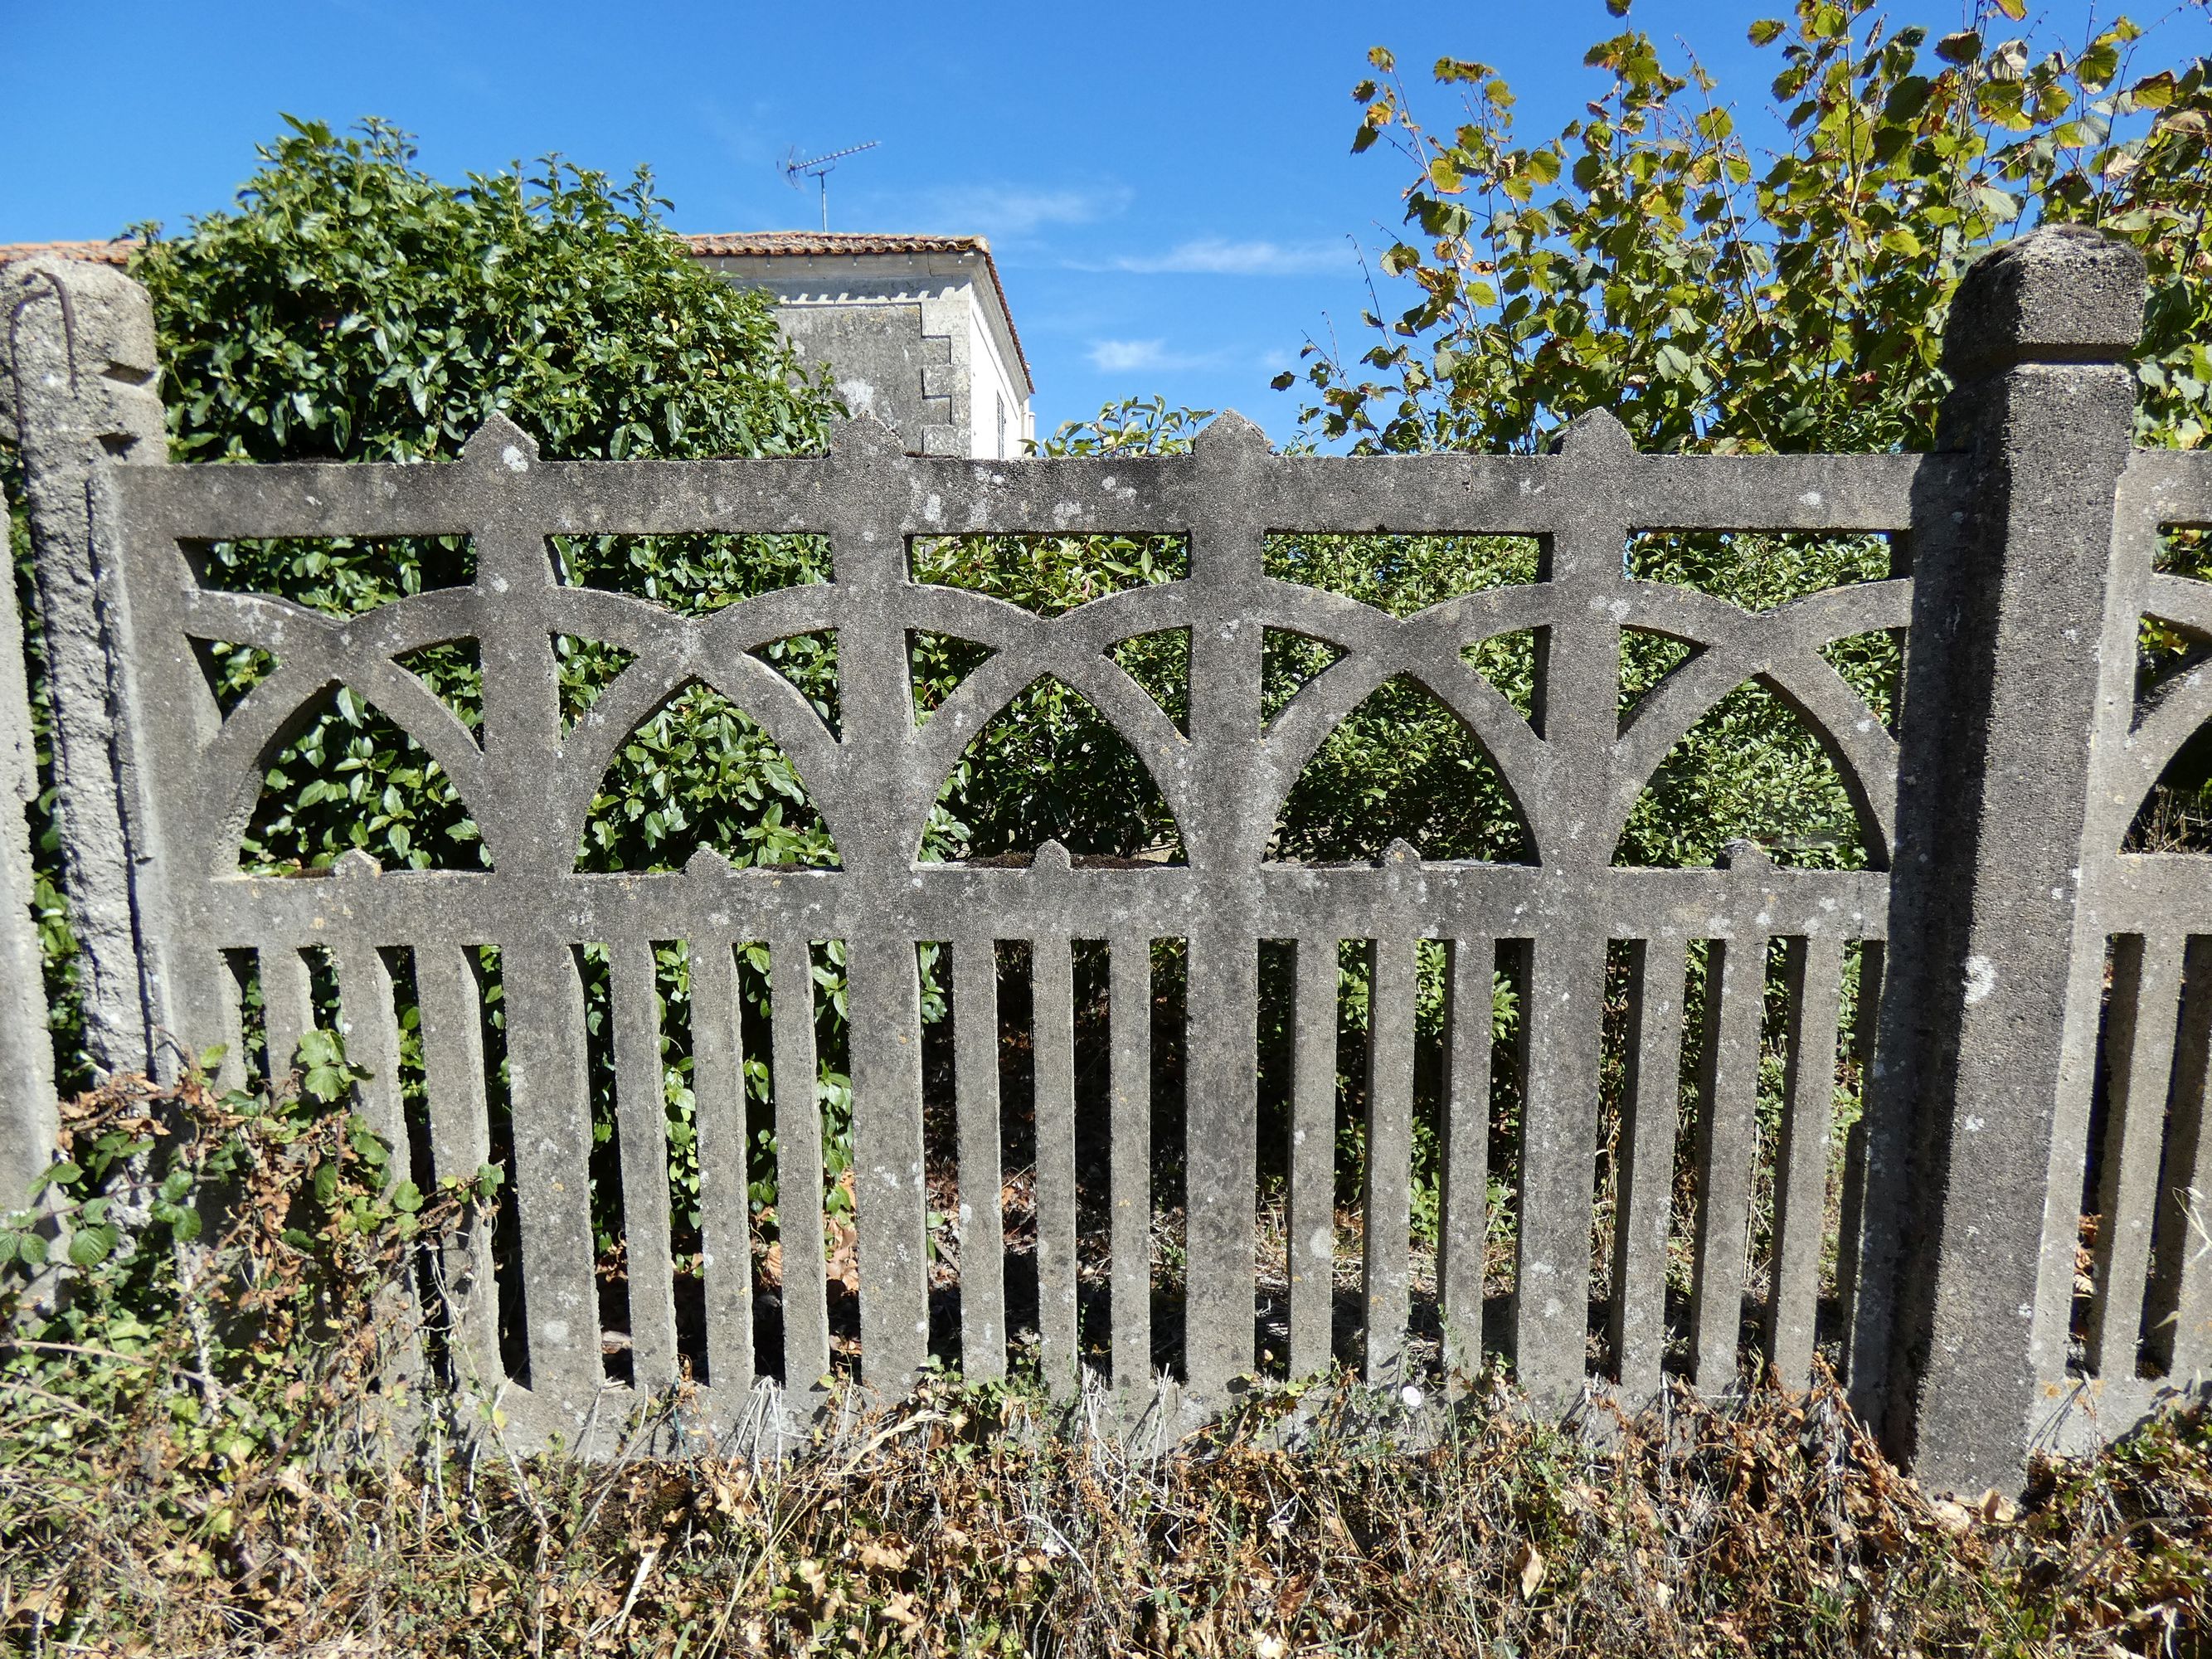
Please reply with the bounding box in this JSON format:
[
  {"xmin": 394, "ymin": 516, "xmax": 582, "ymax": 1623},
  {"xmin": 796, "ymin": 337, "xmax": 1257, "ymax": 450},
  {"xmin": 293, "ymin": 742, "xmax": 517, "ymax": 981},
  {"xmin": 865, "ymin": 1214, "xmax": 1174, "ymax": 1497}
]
[{"xmin": 0, "ymin": 1384, "xmax": 2212, "ymax": 1657}]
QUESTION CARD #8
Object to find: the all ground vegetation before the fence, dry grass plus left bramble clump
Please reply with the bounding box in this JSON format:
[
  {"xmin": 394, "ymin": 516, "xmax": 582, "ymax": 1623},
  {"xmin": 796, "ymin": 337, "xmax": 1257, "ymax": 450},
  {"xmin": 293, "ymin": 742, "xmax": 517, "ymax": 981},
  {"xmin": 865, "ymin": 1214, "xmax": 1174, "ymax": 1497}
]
[{"xmin": 0, "ymin": 1070, "xmax": 2212, "ymax": 1659}]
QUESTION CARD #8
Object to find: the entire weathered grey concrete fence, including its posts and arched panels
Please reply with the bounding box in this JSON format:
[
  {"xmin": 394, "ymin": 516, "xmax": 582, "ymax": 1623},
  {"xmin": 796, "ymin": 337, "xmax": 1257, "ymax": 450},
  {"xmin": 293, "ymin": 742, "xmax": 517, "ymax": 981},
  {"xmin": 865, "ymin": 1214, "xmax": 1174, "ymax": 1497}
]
[{"xmin": 0, "ymin": 230, "xmax": 2212, "ymax": 1491}]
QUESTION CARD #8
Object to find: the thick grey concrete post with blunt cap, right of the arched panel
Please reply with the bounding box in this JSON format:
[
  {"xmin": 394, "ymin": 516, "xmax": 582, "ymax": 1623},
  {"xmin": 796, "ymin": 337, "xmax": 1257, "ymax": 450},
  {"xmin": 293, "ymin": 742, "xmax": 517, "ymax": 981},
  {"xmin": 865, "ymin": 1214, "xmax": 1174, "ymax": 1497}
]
[{"xmin": 1850, "ymin": 226, "xmax": 2143, "ymax": 1493}]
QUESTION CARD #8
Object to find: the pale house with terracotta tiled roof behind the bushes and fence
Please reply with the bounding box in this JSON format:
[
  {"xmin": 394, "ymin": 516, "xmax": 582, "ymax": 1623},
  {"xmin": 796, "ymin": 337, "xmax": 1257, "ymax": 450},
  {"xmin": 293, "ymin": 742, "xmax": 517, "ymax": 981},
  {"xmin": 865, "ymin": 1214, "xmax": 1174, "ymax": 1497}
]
[{"xmin": 0, "ymin": 230, "xmax": 1035, "ymax": 460}]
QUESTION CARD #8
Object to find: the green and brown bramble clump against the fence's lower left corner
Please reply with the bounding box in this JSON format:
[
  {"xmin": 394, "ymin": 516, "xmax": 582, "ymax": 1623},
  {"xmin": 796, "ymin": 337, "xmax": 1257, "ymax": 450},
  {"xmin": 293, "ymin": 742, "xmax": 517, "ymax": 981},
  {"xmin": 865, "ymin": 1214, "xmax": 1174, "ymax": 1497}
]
[{"xmin": 0, "ymin": 1070, "xmax": 500, "ymax": 1504}]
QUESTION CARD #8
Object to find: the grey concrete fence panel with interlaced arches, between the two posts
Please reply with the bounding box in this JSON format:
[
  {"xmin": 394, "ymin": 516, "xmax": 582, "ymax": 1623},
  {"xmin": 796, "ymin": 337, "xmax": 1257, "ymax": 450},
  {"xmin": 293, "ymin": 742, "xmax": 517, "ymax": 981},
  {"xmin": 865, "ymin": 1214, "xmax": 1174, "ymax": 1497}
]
[{"xmin": 73, "ymin": 387, "xmax": 1944, "ymax": 1440}]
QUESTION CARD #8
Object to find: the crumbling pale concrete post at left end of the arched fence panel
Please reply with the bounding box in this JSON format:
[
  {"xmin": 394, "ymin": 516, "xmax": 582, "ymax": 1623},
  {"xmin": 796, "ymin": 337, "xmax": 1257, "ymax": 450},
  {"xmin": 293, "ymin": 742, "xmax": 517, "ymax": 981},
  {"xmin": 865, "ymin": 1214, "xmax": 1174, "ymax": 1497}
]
[{"xmin": 0, "ymin": 256, "xmax": 168, "ymax": 1079}]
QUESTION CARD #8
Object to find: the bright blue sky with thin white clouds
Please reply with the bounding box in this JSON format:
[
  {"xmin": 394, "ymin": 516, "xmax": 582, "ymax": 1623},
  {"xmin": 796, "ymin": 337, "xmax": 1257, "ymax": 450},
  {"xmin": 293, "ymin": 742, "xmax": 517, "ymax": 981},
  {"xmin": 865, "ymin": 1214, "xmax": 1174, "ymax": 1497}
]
[{"xmin": 0, "ymin": 0, "xmax": 2073, "ymax": 440}]
